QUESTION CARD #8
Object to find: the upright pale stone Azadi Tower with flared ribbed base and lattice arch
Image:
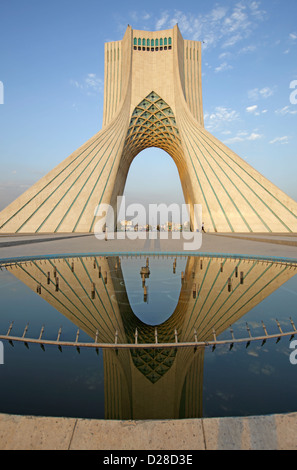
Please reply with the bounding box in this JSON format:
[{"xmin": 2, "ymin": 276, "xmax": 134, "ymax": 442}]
[{"xmin": 0, "ymin": 25, "xmax": 297, "ymax": 233}]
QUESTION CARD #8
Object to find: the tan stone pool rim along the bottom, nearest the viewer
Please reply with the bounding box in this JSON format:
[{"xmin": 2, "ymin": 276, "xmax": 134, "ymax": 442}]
[{"xmin": 0, "ymin": 413, "xmax": 297, "ymax": 452}]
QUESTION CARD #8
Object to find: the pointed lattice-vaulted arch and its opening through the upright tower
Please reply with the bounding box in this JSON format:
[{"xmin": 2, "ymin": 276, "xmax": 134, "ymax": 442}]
[{"xmin": 110, "ymin": 91, "xmax": 191, "ymax": 229}]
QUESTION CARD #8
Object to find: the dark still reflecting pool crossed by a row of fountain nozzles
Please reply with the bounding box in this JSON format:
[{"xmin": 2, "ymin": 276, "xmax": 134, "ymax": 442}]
[{"xmin": 0, "ymin": 255, "xmax": 297, "ymax": 419}]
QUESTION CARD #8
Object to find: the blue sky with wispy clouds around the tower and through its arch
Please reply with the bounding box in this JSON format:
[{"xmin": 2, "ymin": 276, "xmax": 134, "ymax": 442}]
[{"xmin": 0, "ymin": 0, "xmax": 297, "ymax": 210}]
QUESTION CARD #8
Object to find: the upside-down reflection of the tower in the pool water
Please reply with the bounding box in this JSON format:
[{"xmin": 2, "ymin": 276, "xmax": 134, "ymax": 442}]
[{"xmin": 8, "ymin": 256, "xmax": 296, "ymax": 419}]
